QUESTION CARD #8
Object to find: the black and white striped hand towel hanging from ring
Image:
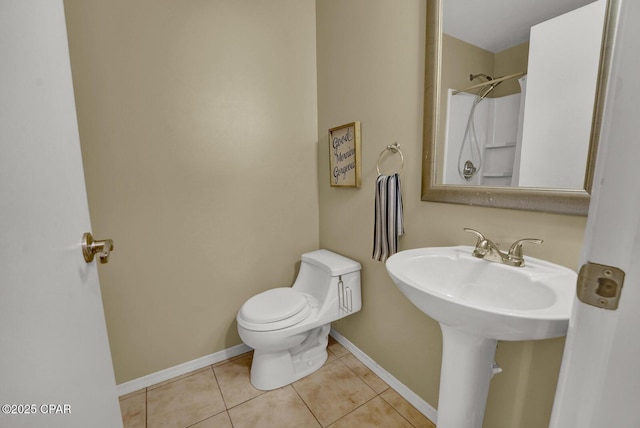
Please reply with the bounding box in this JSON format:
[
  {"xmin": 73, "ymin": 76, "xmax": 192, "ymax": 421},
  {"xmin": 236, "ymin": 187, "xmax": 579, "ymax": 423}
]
[{"xmin": 372, "ymin": 174, "xmax": 404, "ymax": 262}]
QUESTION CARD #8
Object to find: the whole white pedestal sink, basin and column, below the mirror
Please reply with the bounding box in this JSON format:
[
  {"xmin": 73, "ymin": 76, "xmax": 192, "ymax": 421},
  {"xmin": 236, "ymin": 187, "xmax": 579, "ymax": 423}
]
[{"xmin": 386, "ymin": 246, "xmax": 577, "ymax": 428}]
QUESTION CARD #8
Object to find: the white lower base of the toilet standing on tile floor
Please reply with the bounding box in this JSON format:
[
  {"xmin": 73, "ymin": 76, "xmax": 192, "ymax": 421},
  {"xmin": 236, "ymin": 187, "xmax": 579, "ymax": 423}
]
[{"xmin": 251, "ymin": 324, "xmax": 331, "ymax": 391}]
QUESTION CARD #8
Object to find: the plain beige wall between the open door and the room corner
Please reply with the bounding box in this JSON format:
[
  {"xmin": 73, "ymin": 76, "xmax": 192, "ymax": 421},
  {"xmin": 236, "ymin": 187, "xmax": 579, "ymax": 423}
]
[{"xmin": 65, "ymin": 0, "xmax": 318, "ymax": 383}]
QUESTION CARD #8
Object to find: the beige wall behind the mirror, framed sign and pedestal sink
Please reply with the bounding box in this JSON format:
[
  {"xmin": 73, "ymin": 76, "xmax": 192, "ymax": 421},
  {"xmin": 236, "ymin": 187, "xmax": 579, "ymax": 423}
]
[{"xmin": 316, "ymin": 0, "xmax": 585, "ymax": 428}]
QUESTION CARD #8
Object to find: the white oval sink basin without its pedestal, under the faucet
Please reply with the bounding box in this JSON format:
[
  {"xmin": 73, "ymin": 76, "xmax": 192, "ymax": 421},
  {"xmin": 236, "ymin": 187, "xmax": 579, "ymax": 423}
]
[{"xmin": 386, "ymin": 246, "xmax": 576, "ymax": 340}]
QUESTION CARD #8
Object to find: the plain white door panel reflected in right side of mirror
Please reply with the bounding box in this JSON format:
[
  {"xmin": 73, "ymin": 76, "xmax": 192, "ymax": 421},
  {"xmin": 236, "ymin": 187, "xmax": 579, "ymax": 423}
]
[{"xmin": 518, "ymin": 0, "xmax": 606, "ymax": 189}]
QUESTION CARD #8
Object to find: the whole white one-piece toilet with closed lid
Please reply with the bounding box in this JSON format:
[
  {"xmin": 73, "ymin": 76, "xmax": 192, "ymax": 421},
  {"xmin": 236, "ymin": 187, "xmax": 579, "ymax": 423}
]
[{"xmin": 236, "ymin": 250, "xmax": 362, "ymax": 390}]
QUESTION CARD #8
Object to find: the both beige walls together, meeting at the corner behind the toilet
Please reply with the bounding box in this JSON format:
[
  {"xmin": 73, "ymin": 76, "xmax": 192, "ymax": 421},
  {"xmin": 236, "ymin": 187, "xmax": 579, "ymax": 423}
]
[{"xmin": 65, "ymin": 0, "xmax": 585, "ymax": 428}]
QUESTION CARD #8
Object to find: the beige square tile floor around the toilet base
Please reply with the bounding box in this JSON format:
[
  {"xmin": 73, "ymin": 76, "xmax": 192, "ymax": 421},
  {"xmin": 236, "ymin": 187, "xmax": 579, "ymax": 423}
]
[{"xmin": 120, "ymin": 338, "xmax": 435, "ymax": 428}]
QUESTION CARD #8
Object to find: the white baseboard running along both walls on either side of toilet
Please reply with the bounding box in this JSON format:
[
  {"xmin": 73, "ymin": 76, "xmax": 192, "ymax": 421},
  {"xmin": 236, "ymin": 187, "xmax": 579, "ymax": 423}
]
[{"xmin": 116, "ymin": 328, "xmax": 438, "ymax": 421}]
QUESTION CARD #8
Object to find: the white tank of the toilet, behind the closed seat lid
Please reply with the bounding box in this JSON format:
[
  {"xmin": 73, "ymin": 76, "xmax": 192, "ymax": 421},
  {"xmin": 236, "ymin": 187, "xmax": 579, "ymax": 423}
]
[{"xmin": 293, "ymin": 249, "xmax": 362, "ymax": 319}]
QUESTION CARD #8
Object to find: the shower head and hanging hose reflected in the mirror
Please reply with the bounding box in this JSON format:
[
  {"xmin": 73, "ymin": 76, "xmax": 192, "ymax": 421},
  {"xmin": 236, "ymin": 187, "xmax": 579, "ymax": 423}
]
[{"xmin": 458, "ymin": 73, "xmax": 502, "ymax": 180}]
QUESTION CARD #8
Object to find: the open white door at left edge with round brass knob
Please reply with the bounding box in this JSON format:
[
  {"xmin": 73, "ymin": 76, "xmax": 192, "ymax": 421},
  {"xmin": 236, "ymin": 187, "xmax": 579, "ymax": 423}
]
[{"xmin": 0, "ymin": 0, "xmax": 122, "ymax": 428}]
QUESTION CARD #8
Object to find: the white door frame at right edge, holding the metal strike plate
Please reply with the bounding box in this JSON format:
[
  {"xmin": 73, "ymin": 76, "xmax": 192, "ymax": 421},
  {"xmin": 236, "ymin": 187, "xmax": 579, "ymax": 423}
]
[{"xmin": 550, "ymin": 0, "xmax": 640, "ymax": 428}]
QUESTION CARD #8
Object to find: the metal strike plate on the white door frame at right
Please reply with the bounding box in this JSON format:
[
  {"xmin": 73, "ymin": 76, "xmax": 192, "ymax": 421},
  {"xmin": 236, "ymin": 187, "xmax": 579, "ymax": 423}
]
[{"xmin": 577, "ymin": 262, "xmax": 624, "ymax": 310}]
